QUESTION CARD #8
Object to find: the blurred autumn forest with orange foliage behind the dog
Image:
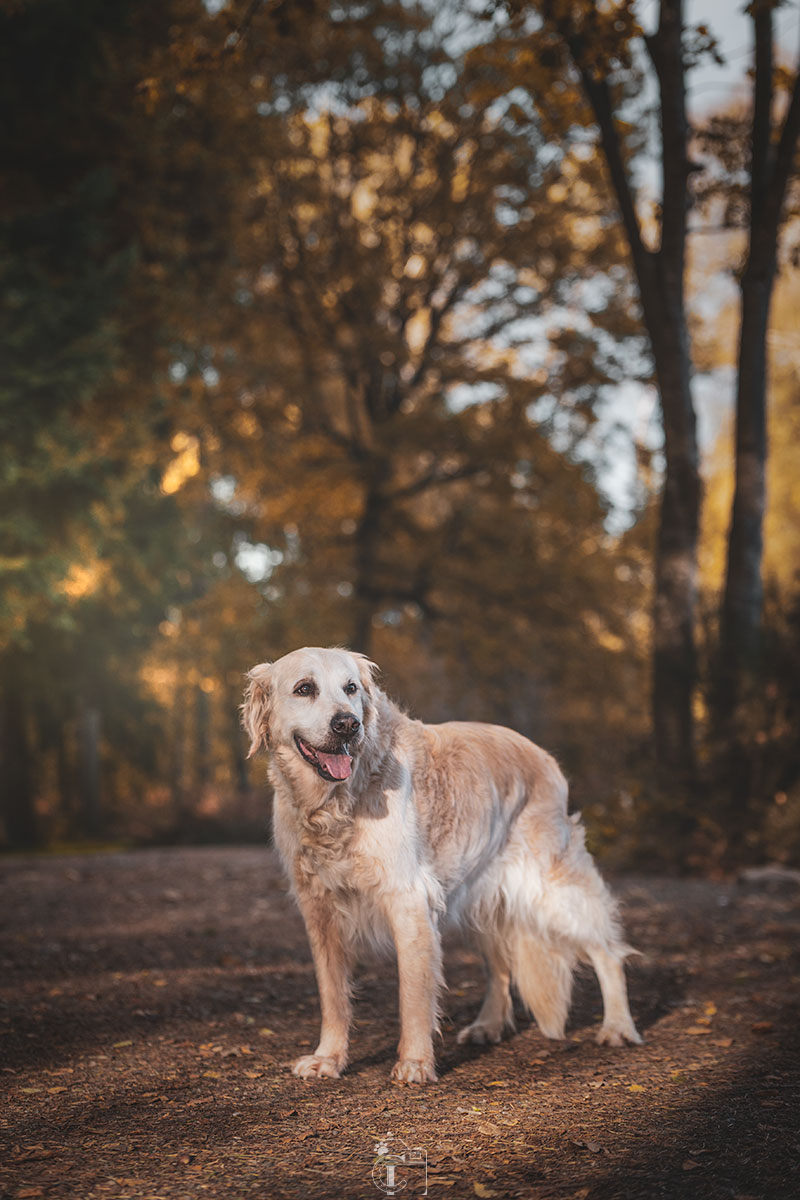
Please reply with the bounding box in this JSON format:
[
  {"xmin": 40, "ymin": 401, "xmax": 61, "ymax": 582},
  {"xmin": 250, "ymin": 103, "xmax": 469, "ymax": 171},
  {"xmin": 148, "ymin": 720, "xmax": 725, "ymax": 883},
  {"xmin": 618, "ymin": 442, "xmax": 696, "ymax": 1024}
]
[{"xmin": 0, "ymin": 0, "xmax": 800, "ymax": 869}]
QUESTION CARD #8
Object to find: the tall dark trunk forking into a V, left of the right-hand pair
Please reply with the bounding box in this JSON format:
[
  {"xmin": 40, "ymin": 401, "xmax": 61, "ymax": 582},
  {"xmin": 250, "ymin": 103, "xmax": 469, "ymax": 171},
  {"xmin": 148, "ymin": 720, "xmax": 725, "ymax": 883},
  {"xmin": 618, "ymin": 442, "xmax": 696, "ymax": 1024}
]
[{"xmin": 549, "ymin": 0, "xmax": 700, "ymax": 790}]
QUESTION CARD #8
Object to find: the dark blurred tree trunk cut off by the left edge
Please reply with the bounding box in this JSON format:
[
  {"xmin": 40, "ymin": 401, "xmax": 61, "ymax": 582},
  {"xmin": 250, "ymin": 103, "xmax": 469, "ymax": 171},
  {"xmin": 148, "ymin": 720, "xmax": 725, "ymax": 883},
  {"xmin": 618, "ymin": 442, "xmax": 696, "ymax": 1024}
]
[{"xmin": 0, "ymin": 655, "xmax": 40, "ymax": 850}]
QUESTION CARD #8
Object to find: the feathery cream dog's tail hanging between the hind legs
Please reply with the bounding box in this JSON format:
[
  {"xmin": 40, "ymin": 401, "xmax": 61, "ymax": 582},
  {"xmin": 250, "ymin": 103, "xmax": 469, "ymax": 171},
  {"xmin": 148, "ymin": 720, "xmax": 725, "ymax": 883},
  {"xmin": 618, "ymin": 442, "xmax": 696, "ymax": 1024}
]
[{"xmin": 509, "ymin": 929, "xmax": 576, "ymax": 1038}]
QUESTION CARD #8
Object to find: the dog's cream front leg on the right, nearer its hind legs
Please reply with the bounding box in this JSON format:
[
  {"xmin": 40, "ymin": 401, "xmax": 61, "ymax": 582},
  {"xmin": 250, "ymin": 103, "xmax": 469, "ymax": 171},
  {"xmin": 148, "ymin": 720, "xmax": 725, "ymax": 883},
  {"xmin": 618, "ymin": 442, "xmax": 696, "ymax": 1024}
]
[{"xmin": 387, "ymin": 894, "xmax": 441, "ymax": 1084}]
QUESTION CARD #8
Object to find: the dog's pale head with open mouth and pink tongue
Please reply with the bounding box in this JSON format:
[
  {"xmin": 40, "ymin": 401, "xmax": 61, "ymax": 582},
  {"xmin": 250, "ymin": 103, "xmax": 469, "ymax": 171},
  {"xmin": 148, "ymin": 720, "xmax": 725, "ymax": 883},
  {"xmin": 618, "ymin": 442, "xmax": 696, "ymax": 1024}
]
[{"xmin": 242, "ymin": 647, "xmax": 375, "ymax": 784}]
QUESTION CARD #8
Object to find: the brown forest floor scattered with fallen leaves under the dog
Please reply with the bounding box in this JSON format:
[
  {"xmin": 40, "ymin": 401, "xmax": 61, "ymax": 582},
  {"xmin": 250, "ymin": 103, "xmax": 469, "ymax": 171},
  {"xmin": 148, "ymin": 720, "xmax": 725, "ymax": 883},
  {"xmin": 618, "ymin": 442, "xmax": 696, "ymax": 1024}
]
[{"xmin": 0, "ymin": 847, "xmax": 800, "ymax": 1200}]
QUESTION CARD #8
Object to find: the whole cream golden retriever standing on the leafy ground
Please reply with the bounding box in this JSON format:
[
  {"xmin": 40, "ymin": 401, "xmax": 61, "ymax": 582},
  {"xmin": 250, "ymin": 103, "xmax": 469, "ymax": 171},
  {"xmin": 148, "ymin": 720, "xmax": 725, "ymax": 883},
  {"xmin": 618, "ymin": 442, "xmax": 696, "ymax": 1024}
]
[{"xmin": 242, "ymin": 648, "xmax": 642, "ymax": 1084}]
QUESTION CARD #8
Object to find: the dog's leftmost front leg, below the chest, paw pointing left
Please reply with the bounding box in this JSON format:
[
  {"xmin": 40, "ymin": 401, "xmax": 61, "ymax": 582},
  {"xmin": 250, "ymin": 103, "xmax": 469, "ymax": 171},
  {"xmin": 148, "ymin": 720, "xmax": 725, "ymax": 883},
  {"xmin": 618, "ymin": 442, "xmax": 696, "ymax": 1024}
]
[{"xmin": 291, "ymin": 894, "xmax": 351, "ymax": 1079}]
